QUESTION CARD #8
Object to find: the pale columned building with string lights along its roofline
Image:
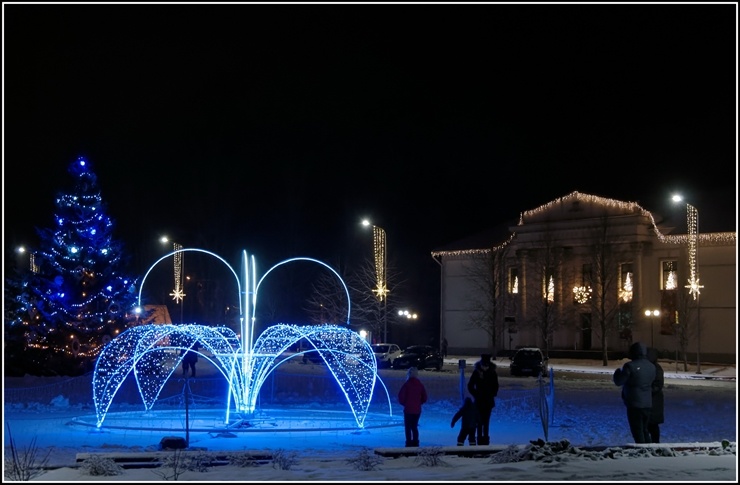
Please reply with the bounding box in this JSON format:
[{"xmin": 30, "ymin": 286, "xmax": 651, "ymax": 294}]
[{"xmin": 432, "ymin": 192, "xmax": 738, "ymax": 363}]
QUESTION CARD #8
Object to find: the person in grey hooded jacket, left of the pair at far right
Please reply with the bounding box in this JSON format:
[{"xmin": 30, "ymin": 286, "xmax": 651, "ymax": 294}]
[{"xmin": 613, "ymin": 342, "xmax": 656, "ymax": 443}]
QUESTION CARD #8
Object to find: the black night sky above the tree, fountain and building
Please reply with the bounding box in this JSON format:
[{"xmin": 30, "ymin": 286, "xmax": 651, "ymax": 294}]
[{"xmin": 3, "ymin": 3, "xmax": 737, "ymax": 332}]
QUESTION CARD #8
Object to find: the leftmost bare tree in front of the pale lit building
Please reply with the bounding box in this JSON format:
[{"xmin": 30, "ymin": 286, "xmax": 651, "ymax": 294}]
[{"xmin": 466, "ymin": 246, "xmax": 508, "ymax": 355}]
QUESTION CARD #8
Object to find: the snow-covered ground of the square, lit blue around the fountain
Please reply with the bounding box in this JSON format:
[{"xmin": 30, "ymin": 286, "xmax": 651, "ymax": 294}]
[{"xmin": 3, "ymin": 356, "xmax": 737, "ymax": 483}]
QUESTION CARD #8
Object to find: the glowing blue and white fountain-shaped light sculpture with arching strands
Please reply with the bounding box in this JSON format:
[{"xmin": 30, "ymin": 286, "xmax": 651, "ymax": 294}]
[{"xmin": 93, "ymin": 248, "xmax": 390, "ymax": 428}]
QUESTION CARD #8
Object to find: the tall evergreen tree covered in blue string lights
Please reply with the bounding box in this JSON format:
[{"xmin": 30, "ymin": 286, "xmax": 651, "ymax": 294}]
[{"xmin": 4, "ymin": 158, "xmax": 137, "ymax": 376}]
